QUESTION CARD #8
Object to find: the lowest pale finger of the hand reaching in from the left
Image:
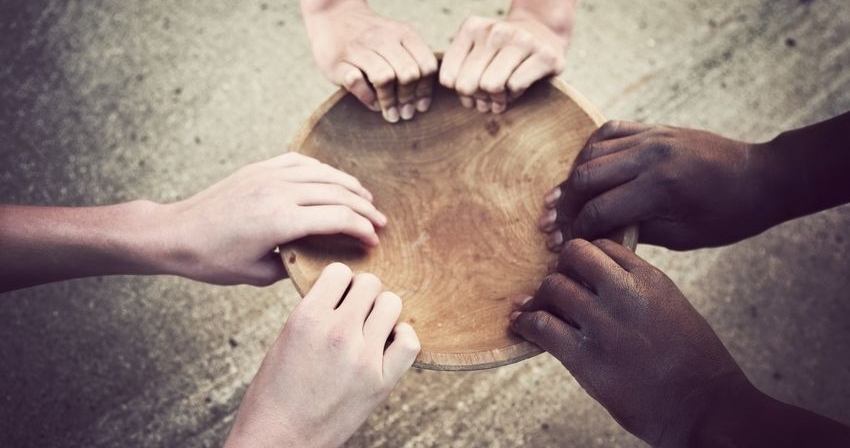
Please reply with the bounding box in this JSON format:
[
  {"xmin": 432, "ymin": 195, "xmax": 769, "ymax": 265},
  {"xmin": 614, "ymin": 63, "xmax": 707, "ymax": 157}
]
[{"xmin": 279, "ymin": 205, "xmax": 378, "ymax": 246}]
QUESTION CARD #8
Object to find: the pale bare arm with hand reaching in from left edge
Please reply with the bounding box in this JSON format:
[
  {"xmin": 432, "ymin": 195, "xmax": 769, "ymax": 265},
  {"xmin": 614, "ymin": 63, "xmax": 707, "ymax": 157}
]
[{"xmin": 0, "ymin": 153, "xmax": 387, "ymax": 292}]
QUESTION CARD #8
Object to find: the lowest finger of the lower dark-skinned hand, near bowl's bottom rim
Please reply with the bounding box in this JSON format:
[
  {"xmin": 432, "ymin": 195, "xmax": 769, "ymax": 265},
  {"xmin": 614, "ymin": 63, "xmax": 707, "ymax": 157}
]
[{"xmin": 511, "ymin": 310, "xmax": 583, "ymax": 370}]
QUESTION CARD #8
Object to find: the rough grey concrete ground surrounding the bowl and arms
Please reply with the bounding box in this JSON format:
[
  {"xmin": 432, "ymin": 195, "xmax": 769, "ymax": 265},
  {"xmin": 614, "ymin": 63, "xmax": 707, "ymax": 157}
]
[{"xmin": 0, "ymin": 0, "xmax": 850, "ymax": 448}]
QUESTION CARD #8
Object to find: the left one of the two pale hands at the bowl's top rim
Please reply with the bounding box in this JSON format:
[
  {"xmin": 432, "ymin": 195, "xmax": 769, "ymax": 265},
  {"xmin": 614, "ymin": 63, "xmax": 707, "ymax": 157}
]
[{"xmin": 302, "ymin": 0, "xmax": 437, "ymax": 123}]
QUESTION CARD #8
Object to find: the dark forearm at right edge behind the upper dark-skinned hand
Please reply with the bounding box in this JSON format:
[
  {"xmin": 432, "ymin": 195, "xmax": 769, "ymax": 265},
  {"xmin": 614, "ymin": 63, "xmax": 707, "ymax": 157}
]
[{"xmin": 757, "ymin": 112, "xmax": 850, "ymax": 224}]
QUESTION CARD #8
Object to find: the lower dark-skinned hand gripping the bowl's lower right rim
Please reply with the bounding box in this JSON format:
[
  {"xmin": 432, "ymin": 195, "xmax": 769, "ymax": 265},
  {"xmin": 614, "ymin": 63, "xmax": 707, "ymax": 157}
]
[{"xmin": 511, "ymin": 240, "xmax": 744, "ymax": 446}]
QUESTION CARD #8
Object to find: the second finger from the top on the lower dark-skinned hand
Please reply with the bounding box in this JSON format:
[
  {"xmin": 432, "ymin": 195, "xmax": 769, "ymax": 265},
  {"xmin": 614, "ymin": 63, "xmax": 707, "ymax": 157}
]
[{"xmin": 555, "ymin": 239, "xmax": 625, "ymax": 292}]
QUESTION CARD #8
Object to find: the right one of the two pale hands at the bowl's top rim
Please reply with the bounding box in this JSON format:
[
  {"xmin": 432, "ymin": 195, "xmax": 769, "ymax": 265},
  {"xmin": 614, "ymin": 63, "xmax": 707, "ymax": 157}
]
[{"xmin": 440, "ymin": 1, "xmax": 574, "ymax": 114}]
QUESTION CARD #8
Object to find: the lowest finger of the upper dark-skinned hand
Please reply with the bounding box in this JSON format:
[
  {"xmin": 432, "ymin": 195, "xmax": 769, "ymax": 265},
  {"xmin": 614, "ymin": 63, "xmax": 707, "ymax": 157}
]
[{"xmin": 572, "ymin": 178, "xmax": 658, "ymax": 239}]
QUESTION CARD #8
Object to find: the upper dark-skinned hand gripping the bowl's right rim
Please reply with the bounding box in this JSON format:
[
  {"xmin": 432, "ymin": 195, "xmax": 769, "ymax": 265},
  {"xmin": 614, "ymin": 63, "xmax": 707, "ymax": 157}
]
[{"xmin": 540, "ymin": 121, "xmax": 776, "ymax": 251}]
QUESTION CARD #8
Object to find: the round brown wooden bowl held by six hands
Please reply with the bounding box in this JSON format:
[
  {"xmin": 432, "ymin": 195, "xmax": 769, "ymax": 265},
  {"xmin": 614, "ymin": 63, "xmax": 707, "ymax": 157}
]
[{"xmin": 280, "ymin": 79, "xmax": 637, "ymax": 370}]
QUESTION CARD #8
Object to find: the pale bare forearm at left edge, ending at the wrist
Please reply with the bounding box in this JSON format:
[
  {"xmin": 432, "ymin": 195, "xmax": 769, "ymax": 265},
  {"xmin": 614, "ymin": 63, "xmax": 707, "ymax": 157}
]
[{"xmin": 0, "ymin": 201, "xmax": 179, "ymax": 291}]
